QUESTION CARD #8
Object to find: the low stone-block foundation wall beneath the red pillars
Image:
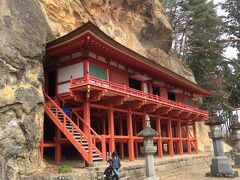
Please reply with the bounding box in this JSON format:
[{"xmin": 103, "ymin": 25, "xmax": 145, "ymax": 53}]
[{"xmin": 22, "ymin": 155, "xmax": 212, "ymax": 180}]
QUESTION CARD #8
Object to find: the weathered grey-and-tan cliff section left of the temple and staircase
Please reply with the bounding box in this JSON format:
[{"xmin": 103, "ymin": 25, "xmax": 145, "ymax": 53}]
[{"xmin": 0, "ymin": 0, "xmax": 50, "ymax": 179}]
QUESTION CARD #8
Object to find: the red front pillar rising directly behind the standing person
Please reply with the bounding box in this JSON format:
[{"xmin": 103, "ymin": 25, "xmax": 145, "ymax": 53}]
[{"xmin": 108, "ymin": 104, "xmax": 115, "ymax": 153}]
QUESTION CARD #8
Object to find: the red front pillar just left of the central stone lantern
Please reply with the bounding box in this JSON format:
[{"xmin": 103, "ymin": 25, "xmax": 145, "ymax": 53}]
[{"xmin": 127, "ymin": 110, "xmax": 134, "ymax": 161}]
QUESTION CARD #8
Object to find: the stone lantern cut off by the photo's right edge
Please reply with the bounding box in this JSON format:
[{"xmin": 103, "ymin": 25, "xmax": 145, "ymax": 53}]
[{"xmin": 230, "ymin": 115, "xmax": 240, "ymax": 168}]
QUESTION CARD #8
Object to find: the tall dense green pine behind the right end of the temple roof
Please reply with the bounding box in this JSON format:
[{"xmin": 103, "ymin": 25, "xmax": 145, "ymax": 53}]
[{"xmin": 186, "ymin": 0, "xmax": 223, "ymax": 90}]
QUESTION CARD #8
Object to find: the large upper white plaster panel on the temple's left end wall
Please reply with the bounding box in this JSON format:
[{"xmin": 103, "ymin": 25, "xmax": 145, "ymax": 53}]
[{"xmin": 58, "ymin": 62, "xmax": 83, "ymax": 82}]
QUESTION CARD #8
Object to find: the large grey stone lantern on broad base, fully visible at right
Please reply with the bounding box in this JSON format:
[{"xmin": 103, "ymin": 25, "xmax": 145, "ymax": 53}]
[{"xmin": 205, "ymin": 110, "xmax": 238, "ymax": 177}]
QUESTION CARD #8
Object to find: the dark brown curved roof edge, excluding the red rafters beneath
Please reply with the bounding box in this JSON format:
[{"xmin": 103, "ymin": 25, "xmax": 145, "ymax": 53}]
[{"xmin": 46, "ymin": 22, "xmax": 211, "ymax": 96}]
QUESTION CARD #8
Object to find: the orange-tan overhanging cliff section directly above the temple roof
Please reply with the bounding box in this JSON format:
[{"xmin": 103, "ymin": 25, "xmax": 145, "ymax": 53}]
[{"xmin": 40, "ymin": 0, "xmax": 195, "ymax": 82}]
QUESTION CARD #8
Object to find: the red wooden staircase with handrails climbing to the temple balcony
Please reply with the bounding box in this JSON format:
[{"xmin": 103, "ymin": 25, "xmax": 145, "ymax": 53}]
[{"xmin": 44, "ymin": 93, "xmax": 106, "ymax": 165}]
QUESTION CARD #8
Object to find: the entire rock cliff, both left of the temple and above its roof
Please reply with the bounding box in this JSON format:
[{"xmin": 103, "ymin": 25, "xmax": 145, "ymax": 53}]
[{"xmin": 0, "ymin": 0, "xmax": 198, "ymax": 179}]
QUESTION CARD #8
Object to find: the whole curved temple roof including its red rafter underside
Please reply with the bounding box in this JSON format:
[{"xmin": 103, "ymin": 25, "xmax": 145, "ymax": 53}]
[{"xmin": 46, "ymin": 22, "xmax": 211, "ymax": 96}]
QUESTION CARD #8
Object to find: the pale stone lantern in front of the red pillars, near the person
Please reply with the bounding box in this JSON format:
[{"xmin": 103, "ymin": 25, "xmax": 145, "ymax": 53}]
[{"xmin": 137, "ymin": 115, "xmax": 160, "ymax": 180}]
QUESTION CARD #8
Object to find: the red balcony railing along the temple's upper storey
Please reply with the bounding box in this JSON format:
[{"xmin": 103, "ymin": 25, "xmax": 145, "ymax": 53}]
[{"xmin": 70, "ymin": 75, "xmax": 208, "ymax": 116}]
